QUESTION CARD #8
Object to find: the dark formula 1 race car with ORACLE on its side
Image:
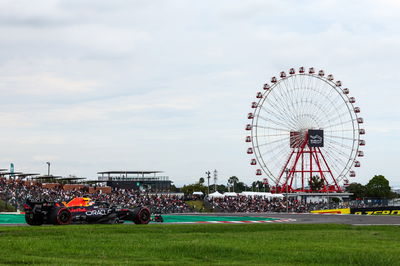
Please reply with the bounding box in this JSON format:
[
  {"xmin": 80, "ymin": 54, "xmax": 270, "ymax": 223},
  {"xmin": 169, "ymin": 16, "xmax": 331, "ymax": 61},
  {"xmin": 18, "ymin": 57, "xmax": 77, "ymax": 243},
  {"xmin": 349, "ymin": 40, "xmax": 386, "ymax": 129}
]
[{"xmin": 24, "ymin": 198, "xmax": 158, "ymax": 225}]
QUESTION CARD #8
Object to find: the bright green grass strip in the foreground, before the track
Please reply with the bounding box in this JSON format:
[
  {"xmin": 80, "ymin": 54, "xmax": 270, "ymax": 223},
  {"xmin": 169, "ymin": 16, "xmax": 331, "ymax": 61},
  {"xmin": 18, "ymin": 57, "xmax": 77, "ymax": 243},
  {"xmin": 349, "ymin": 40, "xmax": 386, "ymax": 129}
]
[{"xmin": 0, "ymin": 224, "xmax": 400, "ymax": 265}]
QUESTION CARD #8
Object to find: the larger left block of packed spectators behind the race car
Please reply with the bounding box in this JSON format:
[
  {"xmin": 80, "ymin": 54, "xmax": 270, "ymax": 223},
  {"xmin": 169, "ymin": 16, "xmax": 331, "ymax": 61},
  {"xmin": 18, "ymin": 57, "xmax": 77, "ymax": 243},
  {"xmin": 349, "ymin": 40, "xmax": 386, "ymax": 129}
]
[{"xmin": 0, "ymin": 178, "xmax": 193, "ymax": 214}]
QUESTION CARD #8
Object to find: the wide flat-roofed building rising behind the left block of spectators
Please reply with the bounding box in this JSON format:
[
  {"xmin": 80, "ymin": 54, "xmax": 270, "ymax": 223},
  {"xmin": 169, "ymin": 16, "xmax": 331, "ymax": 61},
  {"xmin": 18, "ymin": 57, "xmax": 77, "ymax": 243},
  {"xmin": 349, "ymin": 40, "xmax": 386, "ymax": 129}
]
[{"xmin": 97, "ymin": 171, "xmax": 172, "ymax": 192}]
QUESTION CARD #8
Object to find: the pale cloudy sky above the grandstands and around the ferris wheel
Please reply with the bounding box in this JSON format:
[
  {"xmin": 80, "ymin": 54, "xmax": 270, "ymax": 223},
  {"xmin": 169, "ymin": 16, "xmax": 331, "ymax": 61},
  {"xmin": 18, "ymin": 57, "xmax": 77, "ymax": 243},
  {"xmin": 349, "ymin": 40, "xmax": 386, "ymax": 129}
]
[{"xmin": 0, "ymin": 0, "xmax": 400, "ymax": 186}]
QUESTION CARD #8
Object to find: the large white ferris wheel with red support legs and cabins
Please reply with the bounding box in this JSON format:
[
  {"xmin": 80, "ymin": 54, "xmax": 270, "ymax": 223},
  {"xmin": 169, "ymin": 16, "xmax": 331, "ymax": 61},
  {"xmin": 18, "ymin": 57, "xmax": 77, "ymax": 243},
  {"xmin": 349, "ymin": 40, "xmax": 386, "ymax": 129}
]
[{"xmin": 246, "ymin": 67, "xmax": 365, "ymax": 192}]
